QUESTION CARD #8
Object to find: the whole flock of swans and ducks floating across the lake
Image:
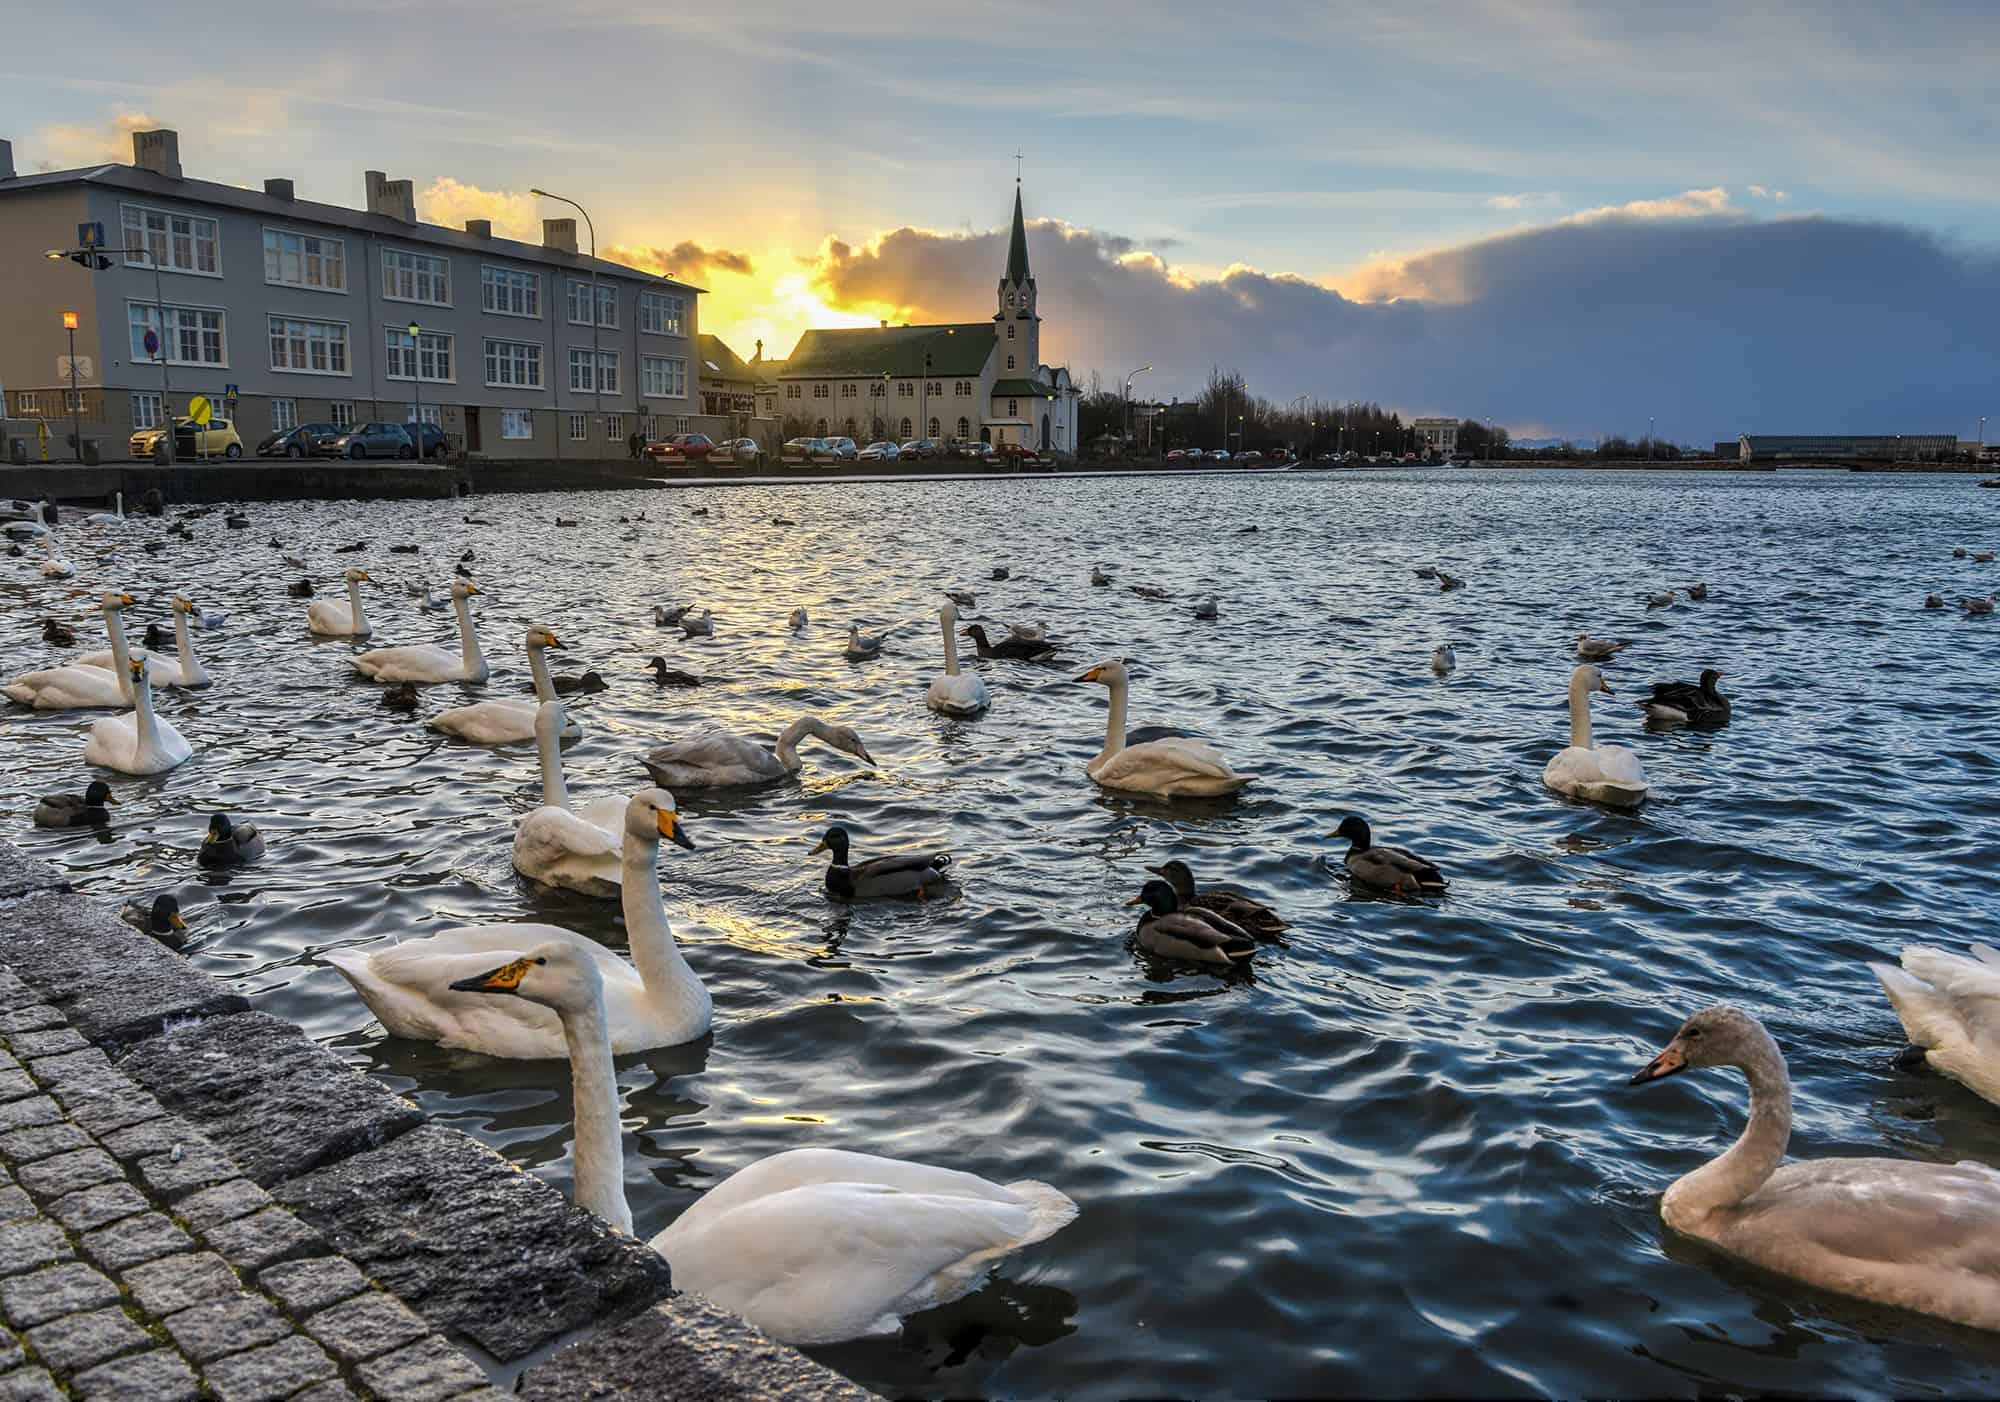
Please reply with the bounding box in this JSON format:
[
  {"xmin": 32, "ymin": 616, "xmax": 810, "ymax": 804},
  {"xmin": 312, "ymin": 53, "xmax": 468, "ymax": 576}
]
[{"xmin": 0, "ymin": 486, "xmax": 2000, "ymax": 1344}]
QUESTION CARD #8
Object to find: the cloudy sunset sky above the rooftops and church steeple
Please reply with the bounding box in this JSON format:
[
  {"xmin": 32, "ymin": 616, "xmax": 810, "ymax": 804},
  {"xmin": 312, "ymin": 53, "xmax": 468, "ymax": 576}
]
[{"xmin": 0, "ymin": 0, "xmax": 2000, "ymax": 444}]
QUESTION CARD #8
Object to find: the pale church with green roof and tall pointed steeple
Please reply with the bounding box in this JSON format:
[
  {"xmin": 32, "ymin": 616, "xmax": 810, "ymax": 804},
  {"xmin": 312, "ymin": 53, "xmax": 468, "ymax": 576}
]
[{"xmin": 750, "ymin": 180, "xmax": 1080, "ymax": 454}]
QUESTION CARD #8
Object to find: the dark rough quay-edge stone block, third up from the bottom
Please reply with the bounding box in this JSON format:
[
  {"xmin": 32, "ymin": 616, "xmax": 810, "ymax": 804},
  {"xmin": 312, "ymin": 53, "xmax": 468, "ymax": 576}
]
[{"xmin": 120, "ymin": 1012, "xmax": 424, "ymax": 1188}]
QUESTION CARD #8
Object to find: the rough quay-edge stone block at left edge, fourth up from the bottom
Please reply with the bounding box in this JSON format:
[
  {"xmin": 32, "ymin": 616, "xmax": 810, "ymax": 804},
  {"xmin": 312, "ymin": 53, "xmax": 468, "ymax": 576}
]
[{"xmin": 0, "ymin": 884, "xmax": 248, "ymax": 1046}]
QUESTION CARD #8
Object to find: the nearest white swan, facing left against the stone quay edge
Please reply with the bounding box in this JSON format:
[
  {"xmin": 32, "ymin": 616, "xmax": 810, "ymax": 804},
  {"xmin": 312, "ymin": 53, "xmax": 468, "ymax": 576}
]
[{"xmin": 454, "ymin": 942, "xmax": 1076, "ymax": 1344}]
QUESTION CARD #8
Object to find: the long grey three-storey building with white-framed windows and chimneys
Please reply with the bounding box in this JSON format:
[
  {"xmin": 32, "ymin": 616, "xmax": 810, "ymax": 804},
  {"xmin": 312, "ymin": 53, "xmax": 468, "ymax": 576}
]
[{"xmin": 0, "ymin": 130, "xmax": 704, "ymax": 458}]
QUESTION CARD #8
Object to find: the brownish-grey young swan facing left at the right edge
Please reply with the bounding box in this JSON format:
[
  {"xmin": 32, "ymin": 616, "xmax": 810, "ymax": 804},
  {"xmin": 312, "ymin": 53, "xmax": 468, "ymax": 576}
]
[{"xmin": 1632, "ymin": 1006, "xmax": 2000, "ymax": 1330}]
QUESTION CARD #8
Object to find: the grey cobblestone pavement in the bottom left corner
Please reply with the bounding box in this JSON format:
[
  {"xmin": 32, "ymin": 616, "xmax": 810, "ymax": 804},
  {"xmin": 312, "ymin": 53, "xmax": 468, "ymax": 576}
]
[{"xmin": 0, "ymin": 966, "xmax": 502, "ymax": 1402}]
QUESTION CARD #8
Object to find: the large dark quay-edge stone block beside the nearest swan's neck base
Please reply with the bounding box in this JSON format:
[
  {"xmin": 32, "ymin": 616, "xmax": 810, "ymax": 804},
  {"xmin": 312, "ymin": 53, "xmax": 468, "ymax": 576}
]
[{"xmin": 270, "ymin": 1124, "xmax": 672, "ymax": 1362}]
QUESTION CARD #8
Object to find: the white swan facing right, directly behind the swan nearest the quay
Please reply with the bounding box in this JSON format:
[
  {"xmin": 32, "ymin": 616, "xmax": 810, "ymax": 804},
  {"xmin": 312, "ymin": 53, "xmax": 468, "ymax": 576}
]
[{"xmin": 326, "ymin": 788, "xmax": 710, "ymax": 1058}]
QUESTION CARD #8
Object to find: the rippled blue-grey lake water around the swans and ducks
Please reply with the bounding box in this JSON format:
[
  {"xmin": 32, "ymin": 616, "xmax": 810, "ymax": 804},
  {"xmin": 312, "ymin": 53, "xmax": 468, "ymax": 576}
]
[{"xmin": 0, "ymin": 472, "xmax": 2000, "ymax": 1396}]
